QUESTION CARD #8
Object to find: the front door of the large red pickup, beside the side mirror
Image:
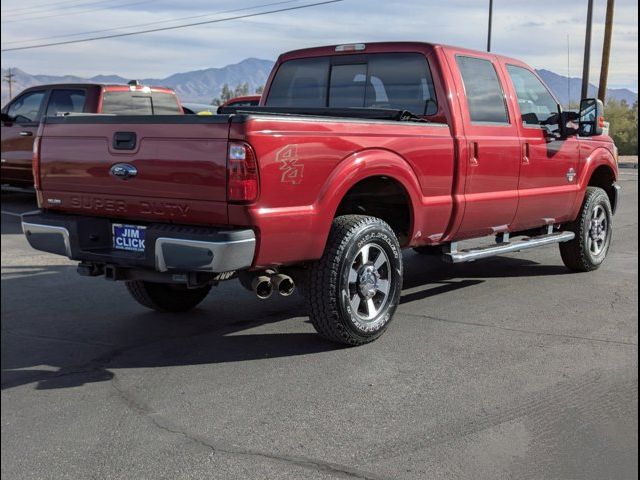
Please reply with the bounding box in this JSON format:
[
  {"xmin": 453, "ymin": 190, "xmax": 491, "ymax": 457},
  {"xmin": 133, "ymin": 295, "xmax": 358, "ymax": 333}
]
[{"xmin": 505, "ymin": 63, "xmax": 580, "ymax": 230}]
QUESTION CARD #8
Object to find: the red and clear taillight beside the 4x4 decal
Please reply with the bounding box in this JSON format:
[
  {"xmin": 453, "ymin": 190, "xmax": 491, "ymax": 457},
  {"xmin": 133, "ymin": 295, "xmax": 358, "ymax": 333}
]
[{"xmin": 227, "ymin": 142, "xmax": 258, "ymax": 202}]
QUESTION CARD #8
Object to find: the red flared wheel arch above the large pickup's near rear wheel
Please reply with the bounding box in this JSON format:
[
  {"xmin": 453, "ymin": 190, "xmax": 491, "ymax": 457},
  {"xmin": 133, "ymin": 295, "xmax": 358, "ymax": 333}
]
[{"xmin": 314, "ymin": 148, "xmax": 422, "ymax": 255}]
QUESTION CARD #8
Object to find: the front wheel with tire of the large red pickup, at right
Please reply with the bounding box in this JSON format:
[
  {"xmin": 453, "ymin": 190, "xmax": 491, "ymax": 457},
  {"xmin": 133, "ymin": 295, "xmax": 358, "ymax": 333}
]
[{"xmin": 560, "ymin": 187, "xmax": 613, "ymax": 272}]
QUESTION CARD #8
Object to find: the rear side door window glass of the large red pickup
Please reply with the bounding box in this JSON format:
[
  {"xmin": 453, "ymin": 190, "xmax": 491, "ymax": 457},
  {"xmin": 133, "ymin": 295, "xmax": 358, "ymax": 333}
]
[{"xmin": 456, "ymin": 56, "xmax": 509, "ymax": 123}]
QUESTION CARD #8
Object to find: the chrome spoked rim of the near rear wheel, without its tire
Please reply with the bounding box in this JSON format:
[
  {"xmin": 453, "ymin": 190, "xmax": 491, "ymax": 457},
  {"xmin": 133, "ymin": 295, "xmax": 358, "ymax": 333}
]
[{"xmin": 348, "ymin": 243, "xmax": 391, "ymax": 323}]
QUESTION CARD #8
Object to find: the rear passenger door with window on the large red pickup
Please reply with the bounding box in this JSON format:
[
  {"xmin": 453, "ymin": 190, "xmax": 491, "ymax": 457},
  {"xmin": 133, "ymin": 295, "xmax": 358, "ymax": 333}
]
[{"xmin": 449, "ymin": 52, "xmax": 521, "ymax": 238}]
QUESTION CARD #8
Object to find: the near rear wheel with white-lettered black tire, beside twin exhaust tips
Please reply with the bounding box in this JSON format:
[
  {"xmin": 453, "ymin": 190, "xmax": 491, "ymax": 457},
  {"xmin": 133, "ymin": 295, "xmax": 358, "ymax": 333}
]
[{"xmin": 307, "ymin": 215, "xmax": 402, "ymax": 345}]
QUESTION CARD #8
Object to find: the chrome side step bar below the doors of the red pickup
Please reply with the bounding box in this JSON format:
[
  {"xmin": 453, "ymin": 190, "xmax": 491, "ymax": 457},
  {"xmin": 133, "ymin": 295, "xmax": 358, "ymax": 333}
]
[{"xmin": 444, "ymin": 232, "xmax": 575, "ymax": 263}]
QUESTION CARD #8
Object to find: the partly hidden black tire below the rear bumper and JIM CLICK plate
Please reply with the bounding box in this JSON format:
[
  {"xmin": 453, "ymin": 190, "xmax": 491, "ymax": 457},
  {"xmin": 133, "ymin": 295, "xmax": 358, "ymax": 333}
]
[{"xmin": 125, "ymin": 280, "xmax": 211, "ymax": 313}]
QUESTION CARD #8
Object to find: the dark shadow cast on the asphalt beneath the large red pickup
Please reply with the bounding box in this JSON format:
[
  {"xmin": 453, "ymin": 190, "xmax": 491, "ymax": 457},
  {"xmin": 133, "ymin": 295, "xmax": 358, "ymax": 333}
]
[{"xmin": 1, "ymin": 252, "xmax": 565, "ymax": 390}]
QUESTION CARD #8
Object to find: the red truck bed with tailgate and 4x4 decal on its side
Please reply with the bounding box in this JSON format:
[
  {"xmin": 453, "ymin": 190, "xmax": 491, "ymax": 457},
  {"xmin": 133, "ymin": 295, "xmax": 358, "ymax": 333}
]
[{"xmin": 39, "ymin": 109, "xmax": 455, "ymax": 263}]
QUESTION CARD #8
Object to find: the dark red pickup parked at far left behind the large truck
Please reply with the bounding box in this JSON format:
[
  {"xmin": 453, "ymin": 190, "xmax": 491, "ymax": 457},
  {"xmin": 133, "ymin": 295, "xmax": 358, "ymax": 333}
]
[{"xmin": 0, "ymin": 80, "xmax": 182, "ymax": 187}]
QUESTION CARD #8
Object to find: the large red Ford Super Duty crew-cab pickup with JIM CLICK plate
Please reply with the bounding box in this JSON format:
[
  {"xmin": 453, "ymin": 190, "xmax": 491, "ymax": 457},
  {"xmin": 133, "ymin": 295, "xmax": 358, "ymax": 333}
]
[{"xmin": 22, "ymin": 42, "xmax": 619, "ymax": 345}]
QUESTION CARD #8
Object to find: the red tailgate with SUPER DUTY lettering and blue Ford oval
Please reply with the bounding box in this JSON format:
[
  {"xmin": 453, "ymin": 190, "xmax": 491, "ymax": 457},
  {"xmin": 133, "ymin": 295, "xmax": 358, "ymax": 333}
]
[{"xmin": 39, "ymin": 116, "xmax": 229, "ymax": 225}]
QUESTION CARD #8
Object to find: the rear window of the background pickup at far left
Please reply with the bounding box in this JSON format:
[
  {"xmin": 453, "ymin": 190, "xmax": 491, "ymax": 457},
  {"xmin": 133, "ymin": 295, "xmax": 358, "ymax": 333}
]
[{"xmin": 102, "ymin": 91, "xmax": 182, "ymax": 115}]
